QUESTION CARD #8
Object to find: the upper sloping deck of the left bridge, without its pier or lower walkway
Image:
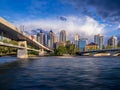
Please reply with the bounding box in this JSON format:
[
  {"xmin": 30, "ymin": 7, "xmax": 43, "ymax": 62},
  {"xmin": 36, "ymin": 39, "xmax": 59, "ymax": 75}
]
[{"xmin": 0, "ymin": 17, "xmax": 53, "ymax": 51}]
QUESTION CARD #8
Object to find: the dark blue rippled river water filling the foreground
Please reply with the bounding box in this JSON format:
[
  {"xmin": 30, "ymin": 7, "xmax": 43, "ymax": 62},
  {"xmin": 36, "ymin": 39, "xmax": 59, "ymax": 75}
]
[{"xmin": 0, "ymin": 57, "xmax": 120, "ymax": 90}]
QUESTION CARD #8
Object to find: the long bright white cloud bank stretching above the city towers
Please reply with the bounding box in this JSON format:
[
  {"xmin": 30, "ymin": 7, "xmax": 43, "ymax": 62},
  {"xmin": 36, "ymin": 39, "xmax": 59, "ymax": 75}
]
[{"xmin": 15, "ymin": 16, "xmax": 105, "ymax": 37}]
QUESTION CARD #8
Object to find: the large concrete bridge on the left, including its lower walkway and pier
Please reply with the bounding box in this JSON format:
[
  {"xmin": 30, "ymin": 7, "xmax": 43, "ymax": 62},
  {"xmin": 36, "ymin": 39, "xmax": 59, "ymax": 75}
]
[{"xmin": 0, "ymin": 17, "xmax": 53, "ymax": 58}]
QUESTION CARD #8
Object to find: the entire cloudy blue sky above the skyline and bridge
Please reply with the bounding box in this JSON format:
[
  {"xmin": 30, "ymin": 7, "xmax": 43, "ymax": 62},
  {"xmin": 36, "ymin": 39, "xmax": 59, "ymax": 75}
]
[{"xmin": 0, "ymin": 0, "xmax": 120, "ymax": 39}]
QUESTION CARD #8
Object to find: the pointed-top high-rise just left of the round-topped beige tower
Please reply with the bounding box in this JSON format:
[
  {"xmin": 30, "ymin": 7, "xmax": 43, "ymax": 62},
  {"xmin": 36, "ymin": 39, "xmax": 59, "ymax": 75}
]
[{"xmin": 47, "ymin": 30, "xmax": 58, "ymax": 48}]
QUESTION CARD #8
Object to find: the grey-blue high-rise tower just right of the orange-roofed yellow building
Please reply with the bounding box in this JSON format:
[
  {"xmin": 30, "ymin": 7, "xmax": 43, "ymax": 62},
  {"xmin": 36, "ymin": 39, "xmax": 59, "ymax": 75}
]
[{"xmin": 94, "ymin": 34, "xmax": 104, "ymax": 49}]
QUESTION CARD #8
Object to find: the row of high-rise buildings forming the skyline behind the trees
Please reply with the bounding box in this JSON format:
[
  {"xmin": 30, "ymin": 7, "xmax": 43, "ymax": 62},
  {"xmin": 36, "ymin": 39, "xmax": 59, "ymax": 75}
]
[{"xmin": 30, "ymin": 30, "xmax": 120, "ymax": 50}]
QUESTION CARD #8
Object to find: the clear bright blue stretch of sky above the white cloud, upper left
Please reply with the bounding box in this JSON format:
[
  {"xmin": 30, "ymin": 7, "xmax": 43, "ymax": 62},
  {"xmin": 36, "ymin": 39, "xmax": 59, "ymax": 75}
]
[{"xmin": 0, "ymin": 0, "xmax": 77, "ymax": 20}]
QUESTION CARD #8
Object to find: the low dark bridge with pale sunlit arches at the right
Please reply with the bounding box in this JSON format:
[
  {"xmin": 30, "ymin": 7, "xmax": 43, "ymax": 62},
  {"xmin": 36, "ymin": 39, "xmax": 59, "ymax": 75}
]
[{"xmin": 77, "ymin": 48, "xmax": 120, "ymax": 56}]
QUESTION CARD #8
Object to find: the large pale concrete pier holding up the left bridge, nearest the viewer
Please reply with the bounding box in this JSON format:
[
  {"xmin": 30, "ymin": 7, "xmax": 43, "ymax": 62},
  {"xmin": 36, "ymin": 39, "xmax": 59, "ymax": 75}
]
[{"xmin": 17, "ymin": 41, "xmax": 28, "ymax": 58}]
